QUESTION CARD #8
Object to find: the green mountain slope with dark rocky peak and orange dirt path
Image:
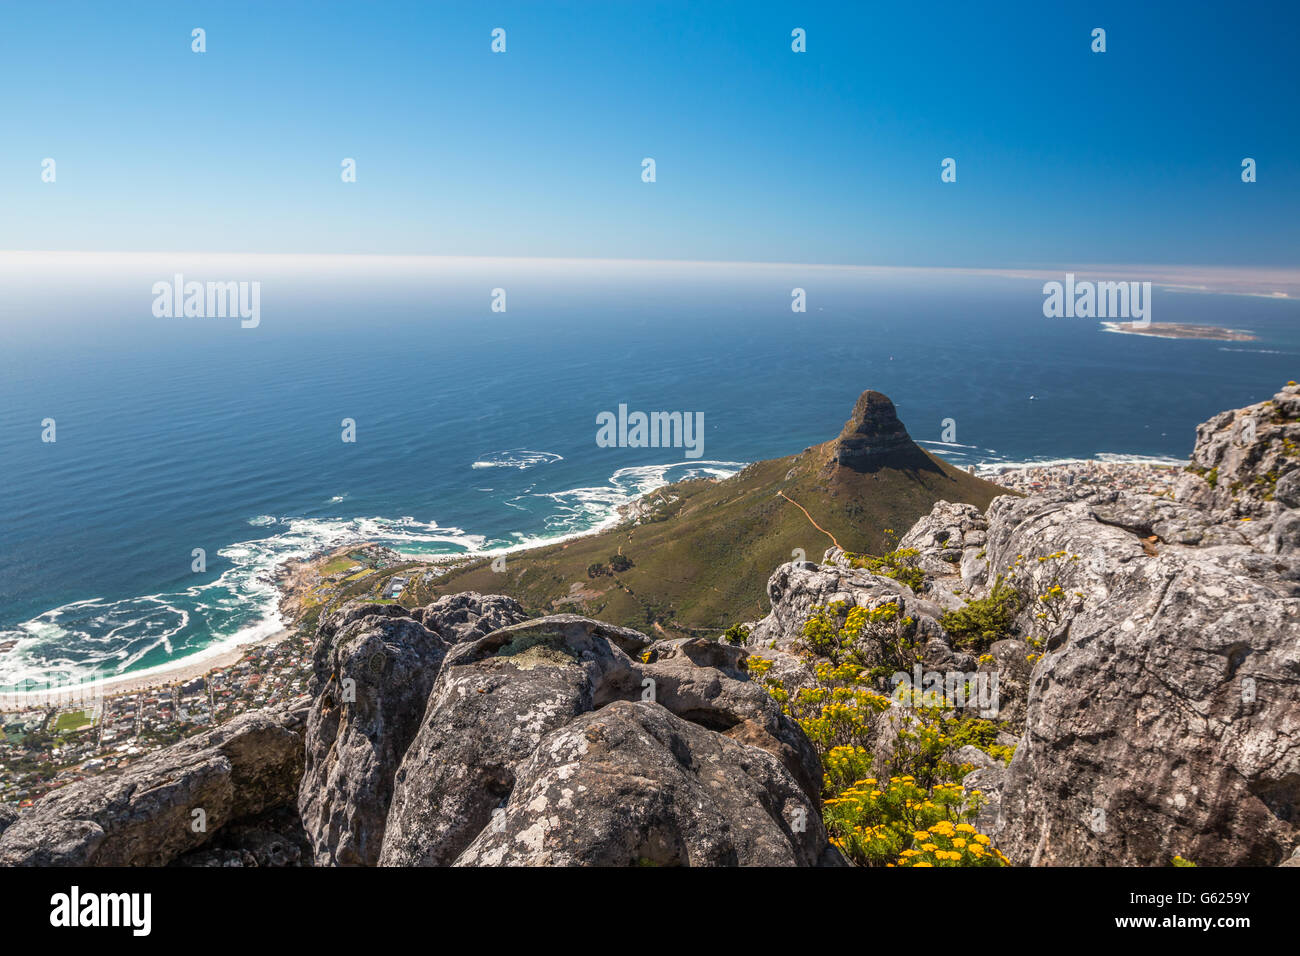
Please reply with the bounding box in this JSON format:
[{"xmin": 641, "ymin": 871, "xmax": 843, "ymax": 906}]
[{"xmin": 408, "ymin": 392, "xmax": 1006, "ymax": 633}]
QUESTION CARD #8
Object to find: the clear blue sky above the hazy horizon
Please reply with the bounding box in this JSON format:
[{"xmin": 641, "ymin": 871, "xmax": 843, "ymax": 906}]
[{"xmin": 0, "ymin": 0, "xmax": 1300, "ymax": 267}]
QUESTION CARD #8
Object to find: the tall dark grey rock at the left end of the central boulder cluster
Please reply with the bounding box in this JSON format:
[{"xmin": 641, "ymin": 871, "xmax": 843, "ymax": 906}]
[{"xmin": 299, "ymin": 593, "xmax": 524, "ymax": 866}]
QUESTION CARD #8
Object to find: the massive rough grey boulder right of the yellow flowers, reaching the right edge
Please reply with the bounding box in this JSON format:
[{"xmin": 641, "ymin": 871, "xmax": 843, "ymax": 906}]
[{"xmin": 961, "ymin": 476, "xmax": 1300, "ymax": 865}]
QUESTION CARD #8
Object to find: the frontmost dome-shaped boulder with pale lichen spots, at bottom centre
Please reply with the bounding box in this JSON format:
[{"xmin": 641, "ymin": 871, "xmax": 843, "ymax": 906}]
[{"xmin": 456, "ymin": 701, "xmax": 839, "ymax": 866}]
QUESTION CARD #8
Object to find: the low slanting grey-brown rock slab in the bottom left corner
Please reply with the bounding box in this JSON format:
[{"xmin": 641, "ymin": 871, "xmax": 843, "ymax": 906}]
[{"xmin": 0, "ymin": 700, "xmax": 307, "ymax": 866}]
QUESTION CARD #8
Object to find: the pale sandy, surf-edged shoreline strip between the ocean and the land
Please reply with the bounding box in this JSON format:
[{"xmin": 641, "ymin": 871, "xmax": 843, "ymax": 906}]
[{"xmin": 0, "ymin": 454, "xmax": 1186, "ymax": 711}]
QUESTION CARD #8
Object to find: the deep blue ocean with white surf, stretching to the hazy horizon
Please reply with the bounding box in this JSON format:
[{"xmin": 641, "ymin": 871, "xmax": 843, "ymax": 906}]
[{"xmin": 0, "ymin": 258, "xmax": 1300, "ymax": 688}]
